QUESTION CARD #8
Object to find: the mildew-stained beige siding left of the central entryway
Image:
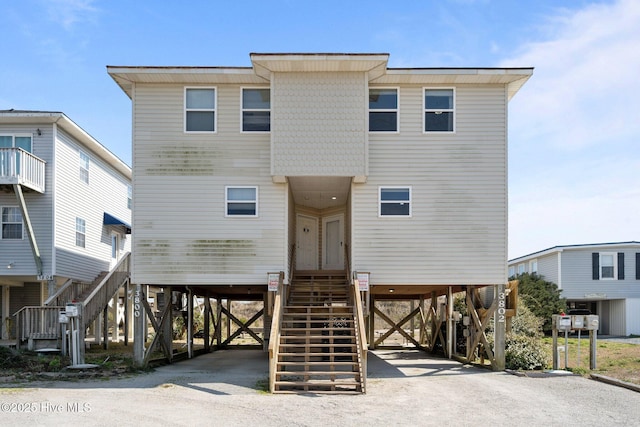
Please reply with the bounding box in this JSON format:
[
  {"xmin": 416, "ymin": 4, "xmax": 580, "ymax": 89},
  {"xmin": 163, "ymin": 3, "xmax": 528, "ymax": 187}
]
[{"xmin": 132, "ymin": 85, "xmax": 288, "ymax": 285}]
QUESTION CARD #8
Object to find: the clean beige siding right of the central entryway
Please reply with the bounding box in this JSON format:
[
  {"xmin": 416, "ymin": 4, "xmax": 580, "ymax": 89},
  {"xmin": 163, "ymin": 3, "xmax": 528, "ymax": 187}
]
[{"xmin": 352, "ymin": 85, "xmax": 507, "ymax": 284}]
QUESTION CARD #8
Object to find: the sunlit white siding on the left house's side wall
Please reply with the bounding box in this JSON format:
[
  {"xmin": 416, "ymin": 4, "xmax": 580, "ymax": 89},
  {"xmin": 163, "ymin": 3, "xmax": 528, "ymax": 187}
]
[{"xmin": 55, "ymin": 128, "xmax": 131, "ymax": 281}]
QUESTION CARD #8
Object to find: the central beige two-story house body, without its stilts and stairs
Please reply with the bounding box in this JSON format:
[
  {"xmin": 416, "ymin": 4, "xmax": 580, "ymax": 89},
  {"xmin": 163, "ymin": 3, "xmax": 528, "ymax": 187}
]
[{"xmin": 107, "ymin": 53, "xmax": 532, "ymax": 382}]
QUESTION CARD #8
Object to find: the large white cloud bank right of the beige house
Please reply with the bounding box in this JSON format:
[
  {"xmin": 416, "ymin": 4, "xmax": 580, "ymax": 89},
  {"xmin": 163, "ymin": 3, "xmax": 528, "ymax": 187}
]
[{"xmin": 502, "ymin": 0, "xmax": 640, "ymax": 258}]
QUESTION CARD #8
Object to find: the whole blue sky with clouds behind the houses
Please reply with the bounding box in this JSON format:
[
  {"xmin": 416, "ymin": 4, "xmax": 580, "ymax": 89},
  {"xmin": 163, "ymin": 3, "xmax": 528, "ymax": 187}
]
[{"xmin": 0, "ymin": 0, "xmax": 640, "ymax": 258}]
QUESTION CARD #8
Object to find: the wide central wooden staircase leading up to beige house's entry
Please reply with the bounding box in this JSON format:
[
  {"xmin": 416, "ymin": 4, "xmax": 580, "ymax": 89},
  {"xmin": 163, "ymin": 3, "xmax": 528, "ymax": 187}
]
[{"xmin": 273, "ymin": 270, "xmax": 365, "ymax": 394}]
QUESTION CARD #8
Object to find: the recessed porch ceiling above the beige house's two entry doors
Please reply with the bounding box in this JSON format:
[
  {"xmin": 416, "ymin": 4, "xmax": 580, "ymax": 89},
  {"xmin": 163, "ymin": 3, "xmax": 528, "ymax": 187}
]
[{"xmin": 288, "ymin": 176, "xmax": 351, "ymax": 209}]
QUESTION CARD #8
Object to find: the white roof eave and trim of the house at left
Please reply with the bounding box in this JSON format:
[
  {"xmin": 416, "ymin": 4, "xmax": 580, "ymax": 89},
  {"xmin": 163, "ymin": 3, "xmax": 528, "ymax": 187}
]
[{"xmin": 0, "ymin": 109, "xmax": 131, "ymax": 179}]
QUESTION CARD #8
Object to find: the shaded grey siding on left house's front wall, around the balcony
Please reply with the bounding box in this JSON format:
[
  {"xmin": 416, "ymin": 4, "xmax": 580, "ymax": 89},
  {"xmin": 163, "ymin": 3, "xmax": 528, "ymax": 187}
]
[{"xmin": 0, "ymin": 124, "xmax": 53, "ymax": 276}]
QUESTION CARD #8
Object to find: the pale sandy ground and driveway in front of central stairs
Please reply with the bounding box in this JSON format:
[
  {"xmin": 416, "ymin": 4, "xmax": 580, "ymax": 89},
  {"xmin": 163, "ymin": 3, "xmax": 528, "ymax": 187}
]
[{"xmin": 0, "ymin": 350, "xmax": 640, "ymax": 427}]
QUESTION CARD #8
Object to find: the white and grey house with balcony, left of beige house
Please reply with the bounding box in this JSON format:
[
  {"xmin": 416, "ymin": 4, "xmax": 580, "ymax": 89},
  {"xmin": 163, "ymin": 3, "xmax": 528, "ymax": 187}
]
[{"xmin": 0, "ymin": 110, "xmax": 132, "ymax": 339}]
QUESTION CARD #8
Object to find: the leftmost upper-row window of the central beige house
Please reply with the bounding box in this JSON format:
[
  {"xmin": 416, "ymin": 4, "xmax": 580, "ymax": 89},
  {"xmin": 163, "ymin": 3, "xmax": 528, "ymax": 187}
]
[{"xmin": 184, "ymin": 88, "xmax": 216, "ymax": 132}]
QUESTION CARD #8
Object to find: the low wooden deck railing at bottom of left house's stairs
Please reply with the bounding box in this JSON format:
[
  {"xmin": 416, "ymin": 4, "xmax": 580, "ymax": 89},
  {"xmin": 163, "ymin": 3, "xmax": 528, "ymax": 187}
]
[{"xmin": 15, "ymin": 306, "xmax": 64, "ymax": 346}]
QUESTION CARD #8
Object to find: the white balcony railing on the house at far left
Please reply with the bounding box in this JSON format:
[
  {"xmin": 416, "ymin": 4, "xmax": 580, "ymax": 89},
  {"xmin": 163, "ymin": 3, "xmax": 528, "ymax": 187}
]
[{"xmin": 0, "ymin": 148, "xmax": 46, "ymax": 193}]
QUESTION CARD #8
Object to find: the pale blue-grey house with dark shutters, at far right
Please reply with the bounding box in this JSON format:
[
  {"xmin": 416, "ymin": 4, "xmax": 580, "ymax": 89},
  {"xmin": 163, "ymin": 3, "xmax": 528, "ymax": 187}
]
[{"xmin": 509, "ymin": 241, "xmax": 640, "ymax": 335}]
